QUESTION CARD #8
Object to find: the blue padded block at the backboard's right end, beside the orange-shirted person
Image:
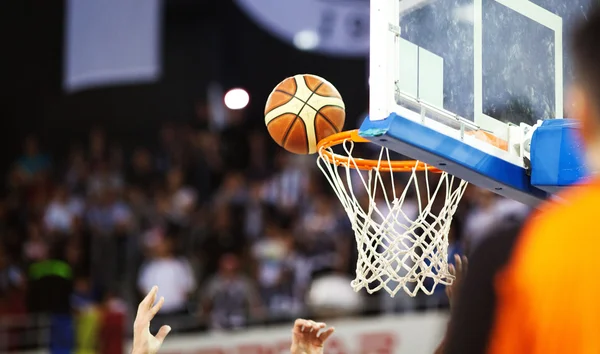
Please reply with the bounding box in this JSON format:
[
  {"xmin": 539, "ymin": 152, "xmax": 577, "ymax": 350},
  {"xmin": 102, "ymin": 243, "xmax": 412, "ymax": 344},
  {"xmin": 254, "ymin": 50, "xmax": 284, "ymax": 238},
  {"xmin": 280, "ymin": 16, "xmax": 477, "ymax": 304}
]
[{"xmin": 531, "ymin": 119, "xmax": 587, "ymax": 193}]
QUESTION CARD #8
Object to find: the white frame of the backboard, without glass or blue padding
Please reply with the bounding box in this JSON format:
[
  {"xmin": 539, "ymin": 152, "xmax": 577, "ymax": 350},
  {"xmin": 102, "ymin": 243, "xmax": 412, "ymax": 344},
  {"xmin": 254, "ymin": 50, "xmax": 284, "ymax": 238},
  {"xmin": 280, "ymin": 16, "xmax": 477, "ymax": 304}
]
[{"xmin": 369, "ymin": 0, "xmax": 540, "ymax": 168}]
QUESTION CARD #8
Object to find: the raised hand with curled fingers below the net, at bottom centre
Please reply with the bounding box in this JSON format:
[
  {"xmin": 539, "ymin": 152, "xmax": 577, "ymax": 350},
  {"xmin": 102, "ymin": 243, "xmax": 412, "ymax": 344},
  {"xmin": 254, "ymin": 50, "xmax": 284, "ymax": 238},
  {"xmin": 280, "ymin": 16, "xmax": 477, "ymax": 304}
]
[{"xmin": 291, "ymin": 318, "xmax": 335, "ymax": 354}]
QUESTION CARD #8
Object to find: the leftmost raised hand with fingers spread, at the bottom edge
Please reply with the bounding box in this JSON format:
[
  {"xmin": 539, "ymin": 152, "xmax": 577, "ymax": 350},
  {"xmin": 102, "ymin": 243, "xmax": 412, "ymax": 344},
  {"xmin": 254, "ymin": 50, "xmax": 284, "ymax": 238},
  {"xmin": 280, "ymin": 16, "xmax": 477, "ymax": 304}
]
[{"xmin": 131, "ymin": 286, "xmax": 171, "ymax": 354}]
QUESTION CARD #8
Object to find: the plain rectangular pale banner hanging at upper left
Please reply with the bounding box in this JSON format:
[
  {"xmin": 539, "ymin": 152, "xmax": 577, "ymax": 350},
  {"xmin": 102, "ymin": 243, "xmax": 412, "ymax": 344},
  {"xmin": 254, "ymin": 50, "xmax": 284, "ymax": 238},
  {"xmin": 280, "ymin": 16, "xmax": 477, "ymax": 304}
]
[{"xmin": 63, "ymin": 0, "xmax": 162, "ymax": 92}]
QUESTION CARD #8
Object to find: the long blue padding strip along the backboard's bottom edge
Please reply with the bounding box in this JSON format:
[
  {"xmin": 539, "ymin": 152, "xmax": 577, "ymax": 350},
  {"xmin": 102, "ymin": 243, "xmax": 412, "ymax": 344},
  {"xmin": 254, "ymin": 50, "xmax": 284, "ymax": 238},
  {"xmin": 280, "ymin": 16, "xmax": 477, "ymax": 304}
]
[{"xmin": 359, "ymin": 113, "xmax": 548, "ymax": 206}]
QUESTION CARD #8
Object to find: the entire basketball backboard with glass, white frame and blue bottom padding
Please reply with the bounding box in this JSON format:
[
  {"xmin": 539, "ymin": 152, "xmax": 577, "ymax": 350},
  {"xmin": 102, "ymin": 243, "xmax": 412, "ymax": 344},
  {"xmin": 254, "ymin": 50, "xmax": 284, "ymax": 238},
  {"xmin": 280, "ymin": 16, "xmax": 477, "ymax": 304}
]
[{"xmin": 360, "ymin": 0, "xmax": 593, "ymax": 205}]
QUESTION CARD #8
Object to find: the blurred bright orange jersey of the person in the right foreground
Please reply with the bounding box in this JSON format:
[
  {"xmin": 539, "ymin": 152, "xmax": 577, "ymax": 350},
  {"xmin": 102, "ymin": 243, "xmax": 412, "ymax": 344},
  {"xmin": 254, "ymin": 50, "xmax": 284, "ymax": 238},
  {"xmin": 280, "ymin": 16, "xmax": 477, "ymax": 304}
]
[{"xmin": 487, "ymin": 180, "xmax": 600, "ymax": 354}]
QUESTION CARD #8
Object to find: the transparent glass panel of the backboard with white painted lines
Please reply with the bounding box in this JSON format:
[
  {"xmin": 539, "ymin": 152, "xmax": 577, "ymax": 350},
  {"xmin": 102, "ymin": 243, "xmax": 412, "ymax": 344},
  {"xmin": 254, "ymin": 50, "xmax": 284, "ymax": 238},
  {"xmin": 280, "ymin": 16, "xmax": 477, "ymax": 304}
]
[{"xmin": 396, "ymin": 0, "xmax": 592, "ymax": 134}]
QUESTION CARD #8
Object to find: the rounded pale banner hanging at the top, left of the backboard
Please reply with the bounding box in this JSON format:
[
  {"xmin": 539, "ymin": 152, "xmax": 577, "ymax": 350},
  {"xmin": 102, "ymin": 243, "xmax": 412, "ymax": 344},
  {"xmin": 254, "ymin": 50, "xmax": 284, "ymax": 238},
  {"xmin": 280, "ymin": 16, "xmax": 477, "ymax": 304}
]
[{"xmin": 236, "ymin": 0, "xmax": 369, "ymax": 56}]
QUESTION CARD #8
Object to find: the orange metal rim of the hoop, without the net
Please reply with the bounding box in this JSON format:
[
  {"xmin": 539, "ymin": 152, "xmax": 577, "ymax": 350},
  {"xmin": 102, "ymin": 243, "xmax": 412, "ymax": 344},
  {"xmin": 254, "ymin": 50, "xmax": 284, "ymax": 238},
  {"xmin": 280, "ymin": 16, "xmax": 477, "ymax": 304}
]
[{"xmin": 317, "ymin": 129, "xmax": 443, "ymax": 173}]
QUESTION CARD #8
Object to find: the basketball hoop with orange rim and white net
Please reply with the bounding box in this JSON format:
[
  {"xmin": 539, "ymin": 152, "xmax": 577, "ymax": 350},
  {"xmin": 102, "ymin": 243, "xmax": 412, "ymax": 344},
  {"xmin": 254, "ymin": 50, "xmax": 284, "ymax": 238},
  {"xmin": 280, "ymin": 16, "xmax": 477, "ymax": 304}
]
[{"xmin": 317, "ymin": 130, "xmax": 467, "ymax": 297}]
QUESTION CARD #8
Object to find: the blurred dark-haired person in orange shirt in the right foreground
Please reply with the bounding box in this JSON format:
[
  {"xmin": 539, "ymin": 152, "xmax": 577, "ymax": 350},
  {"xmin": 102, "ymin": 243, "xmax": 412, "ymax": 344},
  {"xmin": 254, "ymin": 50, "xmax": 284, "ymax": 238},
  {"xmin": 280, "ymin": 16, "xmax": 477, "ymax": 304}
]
[{"xmin": 445, "ymin": 7, "xmax": 600, "ymax": 354}]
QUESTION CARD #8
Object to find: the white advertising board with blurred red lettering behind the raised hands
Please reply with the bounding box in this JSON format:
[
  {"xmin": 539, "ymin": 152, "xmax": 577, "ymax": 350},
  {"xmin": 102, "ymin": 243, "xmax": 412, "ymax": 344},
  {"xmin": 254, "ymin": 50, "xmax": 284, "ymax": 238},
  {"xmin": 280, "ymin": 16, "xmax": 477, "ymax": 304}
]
[{"xmin": 142, "ymin": 313, "xmax": 447, "ymax": 354}]
